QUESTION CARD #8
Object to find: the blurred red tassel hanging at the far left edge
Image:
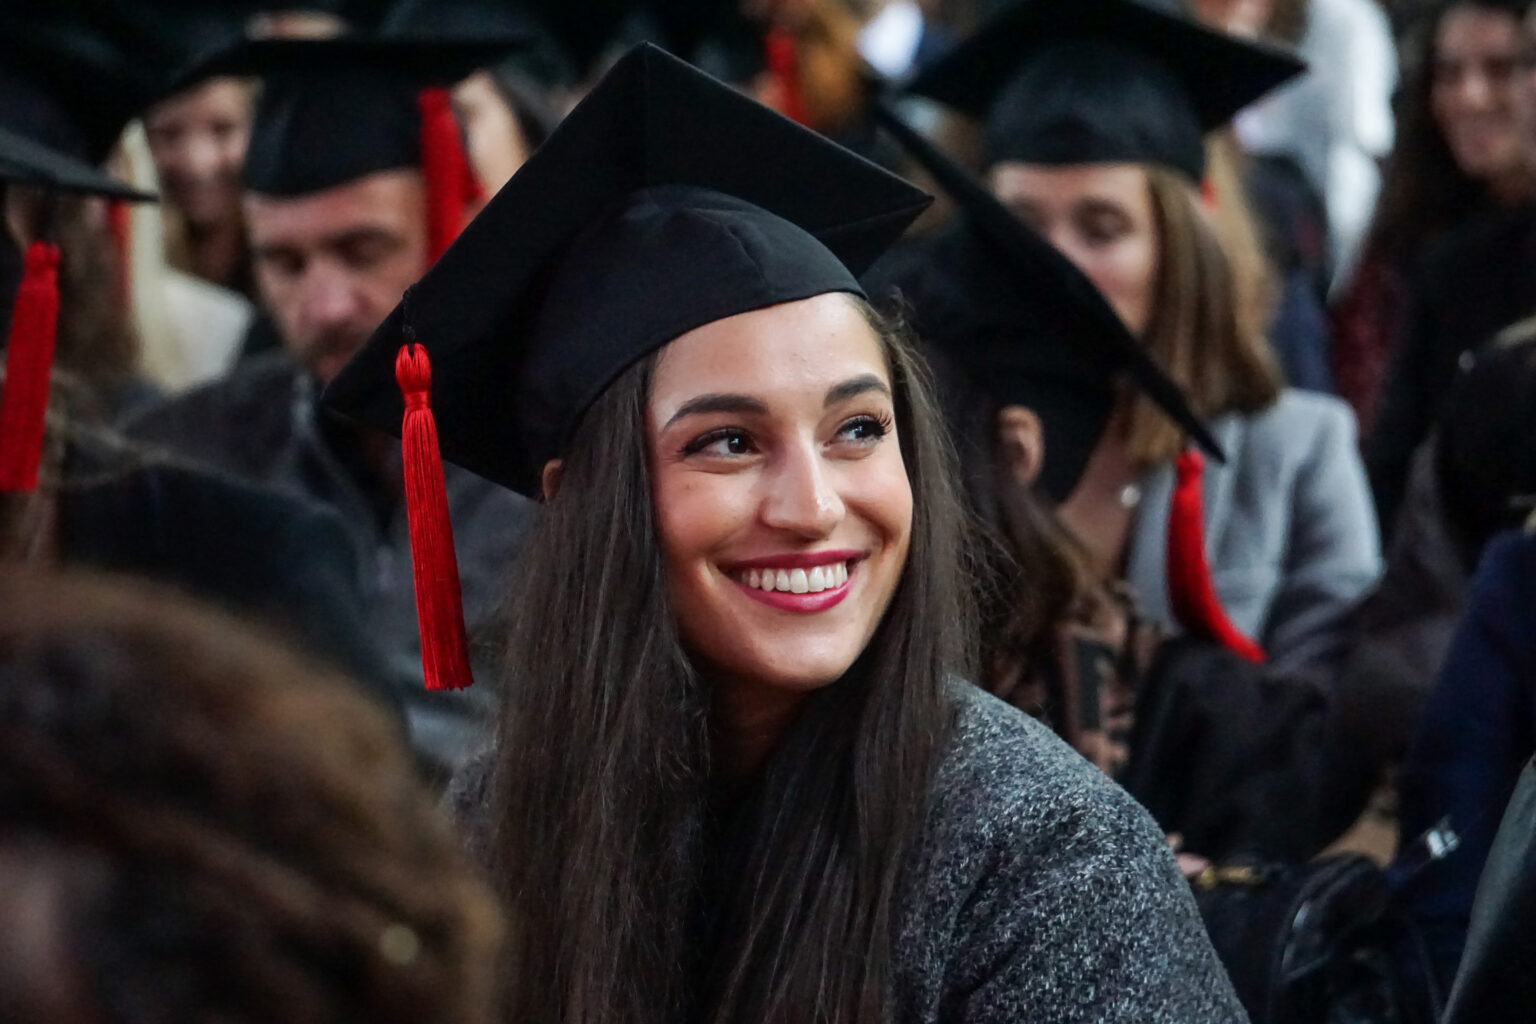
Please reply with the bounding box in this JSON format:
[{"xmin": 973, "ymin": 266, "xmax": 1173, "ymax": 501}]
[{"xmin": 0, "ymin": 241, "xmax": 58, "ymax": 491}]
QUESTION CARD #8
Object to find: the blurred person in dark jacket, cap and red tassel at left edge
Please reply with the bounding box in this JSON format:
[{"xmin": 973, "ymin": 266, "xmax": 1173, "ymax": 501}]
[{"xmin": 0, "ymin": 115, "xmax": 398, "ymax": 724}]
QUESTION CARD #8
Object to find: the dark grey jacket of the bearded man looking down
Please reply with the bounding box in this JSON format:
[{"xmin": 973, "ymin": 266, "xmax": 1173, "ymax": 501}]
[{"xmin": 129, "ymin": 352, "xmax": 533, "ymax": 771}]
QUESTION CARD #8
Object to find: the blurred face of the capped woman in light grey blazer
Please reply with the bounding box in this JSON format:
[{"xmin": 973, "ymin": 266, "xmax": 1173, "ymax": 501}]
[{"xmin": 992, "ymin": 161, "xmax": 1158, "ymax": 336}]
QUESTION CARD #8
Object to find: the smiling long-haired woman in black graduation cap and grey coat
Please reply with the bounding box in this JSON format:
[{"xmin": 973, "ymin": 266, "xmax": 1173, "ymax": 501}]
[{"xmin": 330, "ymin": 48, "xmax": 1241, "ymax": 1024}]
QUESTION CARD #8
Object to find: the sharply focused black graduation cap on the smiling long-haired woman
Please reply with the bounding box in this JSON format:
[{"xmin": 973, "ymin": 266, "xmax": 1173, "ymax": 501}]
[{"xmin": 326, "ymin": 45, "xmax": 929, "ymax": 496}]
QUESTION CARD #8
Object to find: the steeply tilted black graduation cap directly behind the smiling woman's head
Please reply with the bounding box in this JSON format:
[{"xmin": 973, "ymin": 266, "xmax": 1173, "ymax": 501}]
[{"xmin": 872, "ymin": 103, "xmax": 1224, "ymax": 502}]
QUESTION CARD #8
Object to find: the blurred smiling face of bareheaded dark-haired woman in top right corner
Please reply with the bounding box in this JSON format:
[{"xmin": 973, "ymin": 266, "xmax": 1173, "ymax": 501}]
[{"xmin": 1430, "ymin": 6, "xmax": 1536, "ymax": 181}]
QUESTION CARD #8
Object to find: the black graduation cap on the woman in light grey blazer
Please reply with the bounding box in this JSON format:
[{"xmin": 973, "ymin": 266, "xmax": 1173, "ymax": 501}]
[{"xmin": 908, "ymin": 0, "xmax": 1306, "ymax": 181}]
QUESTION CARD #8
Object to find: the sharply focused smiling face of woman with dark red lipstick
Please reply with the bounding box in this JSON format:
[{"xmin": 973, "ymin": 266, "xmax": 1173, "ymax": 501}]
[{"xmin": 647, "ymin": 293, "xmax": 912, "ymax": 705}]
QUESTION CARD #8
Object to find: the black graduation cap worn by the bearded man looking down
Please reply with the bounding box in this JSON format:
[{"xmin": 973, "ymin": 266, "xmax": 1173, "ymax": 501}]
[{"xmin": 163, "ymin": 34, "xmax": 525, "ymax": 197}]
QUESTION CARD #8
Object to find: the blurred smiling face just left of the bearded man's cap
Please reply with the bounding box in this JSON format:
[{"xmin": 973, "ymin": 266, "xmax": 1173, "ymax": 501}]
[{"xmin": 144, "ymin": 78, "xmax": 250, "ymax": 227}]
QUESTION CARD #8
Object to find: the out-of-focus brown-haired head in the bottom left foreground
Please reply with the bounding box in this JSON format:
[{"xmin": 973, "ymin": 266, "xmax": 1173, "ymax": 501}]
[{"xmin": 0, "ymin": 573, "xmax": 502, "ymax": 1024}]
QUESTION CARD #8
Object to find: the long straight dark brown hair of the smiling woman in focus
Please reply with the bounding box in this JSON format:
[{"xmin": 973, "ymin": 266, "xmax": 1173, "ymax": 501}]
[{"xmin": 493, "ymin": 296, "xmax": 971, "ymax": 1024}]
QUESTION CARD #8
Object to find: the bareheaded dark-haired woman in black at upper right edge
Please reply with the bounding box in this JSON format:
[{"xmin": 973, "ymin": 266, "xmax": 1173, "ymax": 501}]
[{"xmin": 1335, "ymin": 0, "xmax": 1536, "ymax": 536}]
